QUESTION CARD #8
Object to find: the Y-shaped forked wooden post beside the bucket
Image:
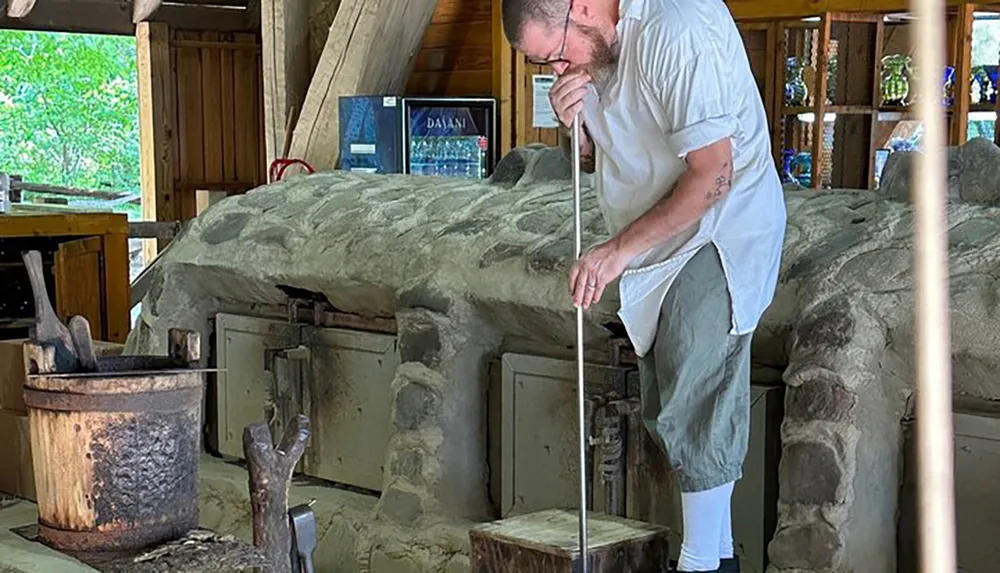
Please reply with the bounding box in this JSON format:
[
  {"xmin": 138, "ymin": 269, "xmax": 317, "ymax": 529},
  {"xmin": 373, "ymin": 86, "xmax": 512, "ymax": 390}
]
[{"xmin": 243, "ymin": 414, "xmax": 311, "ymax": 573}]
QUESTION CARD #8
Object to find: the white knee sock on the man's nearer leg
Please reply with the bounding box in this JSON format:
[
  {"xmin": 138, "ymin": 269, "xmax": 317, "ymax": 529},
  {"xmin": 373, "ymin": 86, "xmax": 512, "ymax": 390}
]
[{"xmin": 677, "ymin": 482, "xmax": 734, "ymax": 571}]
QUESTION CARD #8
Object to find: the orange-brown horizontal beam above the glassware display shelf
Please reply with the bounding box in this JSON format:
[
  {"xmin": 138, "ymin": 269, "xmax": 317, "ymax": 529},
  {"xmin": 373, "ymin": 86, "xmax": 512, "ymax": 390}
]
[{"xmin": 726, "ymin": 0, "xmax": 1000, "ymax": 20}]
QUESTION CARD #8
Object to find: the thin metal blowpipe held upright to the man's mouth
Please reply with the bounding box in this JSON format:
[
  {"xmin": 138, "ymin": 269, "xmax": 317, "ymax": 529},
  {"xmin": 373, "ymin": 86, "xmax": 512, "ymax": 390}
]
[{"xmin": 573, "ymin": 115, "xmax": 589, "ymax": 573}]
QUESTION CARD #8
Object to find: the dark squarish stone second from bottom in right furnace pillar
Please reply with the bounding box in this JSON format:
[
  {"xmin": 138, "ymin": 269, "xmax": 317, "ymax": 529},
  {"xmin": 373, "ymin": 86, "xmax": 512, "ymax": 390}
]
[{"xmin": 779, "ymin": 442, "xmax": 845, "ymax": 505}]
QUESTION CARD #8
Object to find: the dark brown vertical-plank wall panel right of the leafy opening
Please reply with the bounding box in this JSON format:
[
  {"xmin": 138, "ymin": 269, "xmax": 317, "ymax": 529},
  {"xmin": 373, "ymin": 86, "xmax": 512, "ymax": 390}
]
[{"xmin": 170, "ymin": 30, "xmax": 266, "ymax": 220}]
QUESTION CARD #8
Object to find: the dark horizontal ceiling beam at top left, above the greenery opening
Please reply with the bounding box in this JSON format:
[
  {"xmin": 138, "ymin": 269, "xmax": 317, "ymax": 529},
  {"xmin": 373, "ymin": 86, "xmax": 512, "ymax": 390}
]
[{"xmin": 0, "ymin": 0, "xmax": 253, "ymax": 36}]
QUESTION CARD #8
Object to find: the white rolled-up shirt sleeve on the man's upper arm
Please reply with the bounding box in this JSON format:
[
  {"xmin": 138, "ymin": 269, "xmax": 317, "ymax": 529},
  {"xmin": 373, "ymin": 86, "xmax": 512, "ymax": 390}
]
[{"xmin": 640, "ymin": 25, "xmax": 740, "ymax": 157}]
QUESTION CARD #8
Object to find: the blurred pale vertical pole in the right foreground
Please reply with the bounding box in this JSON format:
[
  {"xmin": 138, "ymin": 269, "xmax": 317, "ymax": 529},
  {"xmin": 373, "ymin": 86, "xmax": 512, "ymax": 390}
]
[{"xmin": 912, "ymin": 0, "xmax": 956, "ymax": 573}]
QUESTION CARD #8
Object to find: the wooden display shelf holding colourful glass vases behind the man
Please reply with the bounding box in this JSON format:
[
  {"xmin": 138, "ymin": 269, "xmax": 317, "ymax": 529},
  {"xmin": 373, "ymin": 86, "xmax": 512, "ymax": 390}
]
[{"xmin": 769, "ymin": 4, "xmax": 1000, "ymax": 189}]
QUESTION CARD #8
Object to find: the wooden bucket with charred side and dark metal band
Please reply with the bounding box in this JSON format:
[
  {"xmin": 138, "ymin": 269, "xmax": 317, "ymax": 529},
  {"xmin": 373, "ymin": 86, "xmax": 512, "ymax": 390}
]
[{"xmin": 24, "ymin": 330, "xmax": 204, "ymax": 552}]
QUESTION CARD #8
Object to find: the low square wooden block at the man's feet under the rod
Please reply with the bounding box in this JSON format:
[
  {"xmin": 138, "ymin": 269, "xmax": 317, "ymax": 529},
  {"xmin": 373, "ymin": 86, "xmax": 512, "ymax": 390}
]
[{"xmin": 469, "ymin": 509, "xmax": 670, "ymax": 573}]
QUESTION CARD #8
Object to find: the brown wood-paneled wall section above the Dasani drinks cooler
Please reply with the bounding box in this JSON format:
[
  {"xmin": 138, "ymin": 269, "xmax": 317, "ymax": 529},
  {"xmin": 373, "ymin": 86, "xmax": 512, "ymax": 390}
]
[{"xmin": 406, "ymin": 0, "xmax": 493, "ymax": 96}]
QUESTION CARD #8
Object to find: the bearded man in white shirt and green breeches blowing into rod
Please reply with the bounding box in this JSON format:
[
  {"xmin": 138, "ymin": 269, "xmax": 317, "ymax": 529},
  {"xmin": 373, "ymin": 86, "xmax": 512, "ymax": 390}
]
[{"xmin": 503, "ymin": 0, "xmax": 785, "ymax": 571}]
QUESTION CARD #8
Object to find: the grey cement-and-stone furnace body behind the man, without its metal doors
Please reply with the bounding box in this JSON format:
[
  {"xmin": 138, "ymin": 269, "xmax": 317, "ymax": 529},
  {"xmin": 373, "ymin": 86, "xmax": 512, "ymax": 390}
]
[{"xmin": 127, "ymin": 139, "xmax": 1000, "ymax": 573}]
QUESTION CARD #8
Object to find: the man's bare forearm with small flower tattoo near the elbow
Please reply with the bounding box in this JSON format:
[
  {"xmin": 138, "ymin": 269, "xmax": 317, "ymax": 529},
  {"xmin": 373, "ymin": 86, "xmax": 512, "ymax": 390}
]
[{"xmin": 612, "ymin": 162, "xmax": 733, "ymax": 259}]
